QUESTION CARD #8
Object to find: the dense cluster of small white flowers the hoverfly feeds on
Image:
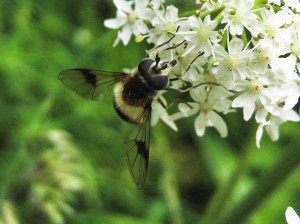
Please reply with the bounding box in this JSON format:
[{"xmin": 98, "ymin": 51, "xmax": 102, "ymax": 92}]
[{"xmin": 104, "ymin": 0, "xmax": 300, "ymax": 147}]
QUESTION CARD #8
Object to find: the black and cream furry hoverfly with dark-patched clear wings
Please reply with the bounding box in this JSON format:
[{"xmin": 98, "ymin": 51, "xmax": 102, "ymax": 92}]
[{"xmin": 59, "ymin": 54, "xmax": 184, "ymax": 189}]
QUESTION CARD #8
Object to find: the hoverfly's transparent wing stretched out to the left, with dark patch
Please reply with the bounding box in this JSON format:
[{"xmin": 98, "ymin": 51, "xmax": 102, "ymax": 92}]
[{"xmin": 58, "ymin": 68, "xmax": 127, "ymax": 100}]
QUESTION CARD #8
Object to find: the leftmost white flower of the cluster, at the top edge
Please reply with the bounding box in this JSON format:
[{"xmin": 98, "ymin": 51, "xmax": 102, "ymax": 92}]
[{"xmin": 104, "ymin": 0, "xmax": 152, "ymax": 46}]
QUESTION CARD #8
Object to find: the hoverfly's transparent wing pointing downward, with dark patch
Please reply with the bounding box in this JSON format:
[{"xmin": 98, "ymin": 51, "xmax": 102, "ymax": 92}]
[{"xmin": 125, "ymin": 102, "xmax": 152, "ymax": 189}]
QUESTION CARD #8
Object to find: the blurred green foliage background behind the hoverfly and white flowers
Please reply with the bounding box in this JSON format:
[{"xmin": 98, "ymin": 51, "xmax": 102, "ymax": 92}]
[{"xmin": 0, "ymin": 0, "xmax": 300, "ymax": 224}]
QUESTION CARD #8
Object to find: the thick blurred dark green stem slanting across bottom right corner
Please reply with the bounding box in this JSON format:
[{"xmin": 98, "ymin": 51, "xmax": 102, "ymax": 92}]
[{"xmin": 218, "ymin": 143, "xmax": 300, "ymax": 224}]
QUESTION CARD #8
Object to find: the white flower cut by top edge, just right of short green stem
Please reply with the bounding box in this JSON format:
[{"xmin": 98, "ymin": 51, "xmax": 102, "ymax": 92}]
[{"xmin": 222, "ymin": 0, "xmax": 260, "ymax": 36}]
